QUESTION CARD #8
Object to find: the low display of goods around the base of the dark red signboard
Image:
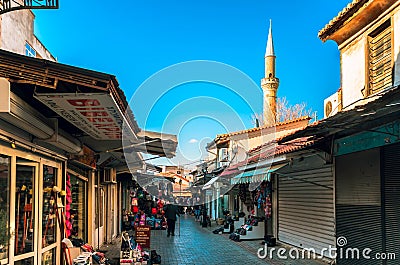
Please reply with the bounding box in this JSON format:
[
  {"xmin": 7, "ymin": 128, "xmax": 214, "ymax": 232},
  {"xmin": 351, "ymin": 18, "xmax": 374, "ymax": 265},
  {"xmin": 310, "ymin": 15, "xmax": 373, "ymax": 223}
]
[{"xmin": 119, "ymin": 232, "xmax": 161, "ymax": 265}]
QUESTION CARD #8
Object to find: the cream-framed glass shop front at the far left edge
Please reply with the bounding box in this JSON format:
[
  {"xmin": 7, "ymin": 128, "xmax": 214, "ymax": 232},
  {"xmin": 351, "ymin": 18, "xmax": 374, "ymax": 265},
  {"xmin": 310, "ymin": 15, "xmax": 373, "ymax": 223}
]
[{"xmin": 0, "ymin": 137, "xmax": 66, "ymax": 264}]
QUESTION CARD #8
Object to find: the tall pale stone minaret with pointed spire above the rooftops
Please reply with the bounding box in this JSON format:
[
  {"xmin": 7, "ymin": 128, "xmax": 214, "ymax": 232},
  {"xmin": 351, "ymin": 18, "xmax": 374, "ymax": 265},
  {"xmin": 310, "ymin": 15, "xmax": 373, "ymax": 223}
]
[{"xmin": 261, "ymin": 20, "xmax": 279, "ymax": 125}]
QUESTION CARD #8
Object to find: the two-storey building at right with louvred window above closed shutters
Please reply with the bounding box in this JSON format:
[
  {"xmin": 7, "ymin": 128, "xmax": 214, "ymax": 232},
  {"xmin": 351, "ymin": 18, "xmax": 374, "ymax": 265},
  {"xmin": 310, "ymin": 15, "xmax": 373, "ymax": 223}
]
[{"xmin": 268, "ymin": 1, "xmax": 400, "ymax": 264}]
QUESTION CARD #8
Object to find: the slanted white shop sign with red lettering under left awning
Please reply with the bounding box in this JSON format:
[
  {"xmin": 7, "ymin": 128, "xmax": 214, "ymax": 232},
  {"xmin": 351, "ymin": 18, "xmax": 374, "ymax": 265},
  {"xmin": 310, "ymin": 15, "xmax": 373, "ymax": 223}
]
[{"xmin": 34, "ymin": 93, "xmax": 132, "ymax": 140}]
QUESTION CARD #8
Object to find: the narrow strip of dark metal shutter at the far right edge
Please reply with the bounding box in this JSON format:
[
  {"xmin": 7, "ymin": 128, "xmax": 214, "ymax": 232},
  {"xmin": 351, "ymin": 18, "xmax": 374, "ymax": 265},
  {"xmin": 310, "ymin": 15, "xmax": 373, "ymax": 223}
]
[{"xmin": 382, "ymin": 144, "xmax": 400, "ymax": 265}]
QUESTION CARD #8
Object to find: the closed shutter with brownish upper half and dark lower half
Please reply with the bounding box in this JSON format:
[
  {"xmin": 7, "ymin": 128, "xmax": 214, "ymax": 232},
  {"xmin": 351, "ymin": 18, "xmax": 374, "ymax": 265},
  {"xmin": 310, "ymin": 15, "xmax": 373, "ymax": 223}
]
[{"xmin": 335, "ymin": 148, "xmax": 382, "ymax": 265}]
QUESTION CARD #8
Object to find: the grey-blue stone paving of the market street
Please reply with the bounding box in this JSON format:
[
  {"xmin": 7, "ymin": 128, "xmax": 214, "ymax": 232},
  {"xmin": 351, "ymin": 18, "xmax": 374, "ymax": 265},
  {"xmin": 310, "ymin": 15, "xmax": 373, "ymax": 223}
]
[{"xmin": 102, "ymin": 216, "xmax": 327, "ymax": 265}]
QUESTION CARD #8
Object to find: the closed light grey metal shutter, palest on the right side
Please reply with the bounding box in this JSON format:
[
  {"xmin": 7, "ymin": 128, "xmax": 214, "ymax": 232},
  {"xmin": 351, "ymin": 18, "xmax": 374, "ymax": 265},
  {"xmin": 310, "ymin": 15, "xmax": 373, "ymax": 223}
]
[{"xmin": 278, "ymin": 166, "xmax": 335, "ymax": 255}]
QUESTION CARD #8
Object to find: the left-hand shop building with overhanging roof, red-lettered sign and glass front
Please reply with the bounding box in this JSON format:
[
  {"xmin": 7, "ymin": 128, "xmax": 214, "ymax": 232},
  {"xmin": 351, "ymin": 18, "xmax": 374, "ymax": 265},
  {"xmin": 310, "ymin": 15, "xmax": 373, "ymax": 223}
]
[{"xmin": 0, "ymin": 47, "xmax": 176, "ymax": 264}]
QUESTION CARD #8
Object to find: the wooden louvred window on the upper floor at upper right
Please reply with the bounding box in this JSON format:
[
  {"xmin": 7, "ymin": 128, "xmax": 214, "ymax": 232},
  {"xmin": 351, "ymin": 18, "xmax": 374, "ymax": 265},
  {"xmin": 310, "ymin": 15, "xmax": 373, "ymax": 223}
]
[{"xmin": 368, "ymin": 20, "xmax": 392, "ymax": 95}]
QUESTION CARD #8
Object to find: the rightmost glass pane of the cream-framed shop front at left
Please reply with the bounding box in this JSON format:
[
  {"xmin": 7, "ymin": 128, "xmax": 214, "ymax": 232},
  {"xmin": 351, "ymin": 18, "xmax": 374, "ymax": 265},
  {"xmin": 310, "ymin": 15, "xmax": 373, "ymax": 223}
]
[{"xmin": 42, "ymin": 165, "xmax": 57, "ymax": 248}]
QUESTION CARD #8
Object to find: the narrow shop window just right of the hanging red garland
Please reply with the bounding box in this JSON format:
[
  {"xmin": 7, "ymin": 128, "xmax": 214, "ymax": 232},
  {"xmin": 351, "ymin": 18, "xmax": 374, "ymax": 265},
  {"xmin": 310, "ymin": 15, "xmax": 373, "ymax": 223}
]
[{"xmin": 70, "ymin": 175, "xmax": 87, "ymax": 241}]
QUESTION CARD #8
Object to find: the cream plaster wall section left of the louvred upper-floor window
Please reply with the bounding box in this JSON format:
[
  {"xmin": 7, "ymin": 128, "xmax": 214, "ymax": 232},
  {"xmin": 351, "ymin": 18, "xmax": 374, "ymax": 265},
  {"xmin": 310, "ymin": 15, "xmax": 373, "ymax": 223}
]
[{"xmin": 341, "ymin": 38, "xmax": 366, "ymax": 108}]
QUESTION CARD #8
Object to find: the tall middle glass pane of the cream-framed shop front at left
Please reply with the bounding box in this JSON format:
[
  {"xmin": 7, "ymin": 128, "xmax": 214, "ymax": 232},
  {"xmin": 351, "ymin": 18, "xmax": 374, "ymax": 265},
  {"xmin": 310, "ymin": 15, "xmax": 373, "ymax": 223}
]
[{"xmin": 14, "ymin": 159, "xmax": 37, "ymax": 255}]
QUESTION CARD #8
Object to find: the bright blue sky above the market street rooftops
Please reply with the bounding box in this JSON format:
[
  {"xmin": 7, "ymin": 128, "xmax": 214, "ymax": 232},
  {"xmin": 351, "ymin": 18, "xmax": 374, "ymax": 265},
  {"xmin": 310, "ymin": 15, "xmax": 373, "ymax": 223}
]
[{"xmin": 35, "ymin": 0, "xmax": 350, "ymax": 167}]
